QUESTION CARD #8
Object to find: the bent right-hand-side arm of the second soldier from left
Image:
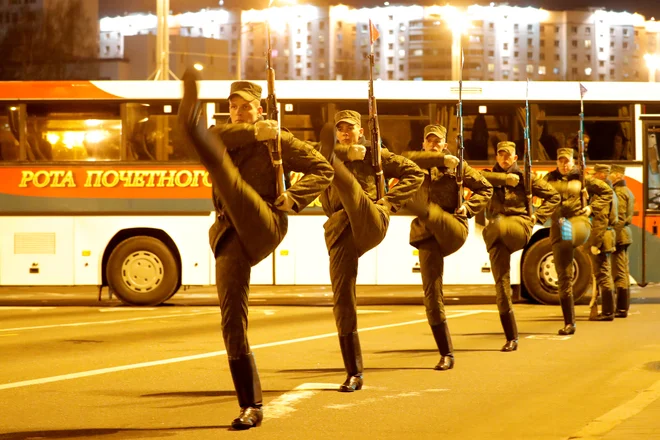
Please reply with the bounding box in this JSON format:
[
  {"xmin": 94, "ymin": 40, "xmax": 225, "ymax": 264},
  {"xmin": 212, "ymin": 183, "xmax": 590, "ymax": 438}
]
[{"xmin": 381, "ymin": 148, "xmax": 424, "ymax": 212}]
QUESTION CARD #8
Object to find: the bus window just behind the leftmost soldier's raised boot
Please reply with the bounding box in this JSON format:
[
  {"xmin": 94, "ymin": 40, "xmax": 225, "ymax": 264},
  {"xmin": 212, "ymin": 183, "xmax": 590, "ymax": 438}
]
[{"xmin": 125, "ymin": 102, "xmax": 199, "ymax": 162}]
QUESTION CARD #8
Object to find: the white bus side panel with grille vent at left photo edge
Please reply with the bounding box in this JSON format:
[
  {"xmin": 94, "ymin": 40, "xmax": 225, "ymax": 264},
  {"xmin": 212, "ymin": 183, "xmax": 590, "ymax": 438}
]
[{"xmin": 0, "ymin": 217, "xmax": 74, "ymax": 286}]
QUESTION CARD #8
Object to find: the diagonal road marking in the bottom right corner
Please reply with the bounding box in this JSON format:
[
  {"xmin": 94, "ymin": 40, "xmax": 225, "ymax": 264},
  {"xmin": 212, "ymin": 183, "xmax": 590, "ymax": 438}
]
[{"xmin": 568, "ymin": 380, "xmax": 660, "ymax": 440}]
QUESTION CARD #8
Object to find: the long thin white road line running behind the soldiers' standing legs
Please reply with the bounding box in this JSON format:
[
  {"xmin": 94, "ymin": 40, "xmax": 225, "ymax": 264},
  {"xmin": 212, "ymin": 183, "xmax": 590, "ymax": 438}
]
[{"xmin": 0, "ymin": 310, "xmax": 481, "ymax": 391}]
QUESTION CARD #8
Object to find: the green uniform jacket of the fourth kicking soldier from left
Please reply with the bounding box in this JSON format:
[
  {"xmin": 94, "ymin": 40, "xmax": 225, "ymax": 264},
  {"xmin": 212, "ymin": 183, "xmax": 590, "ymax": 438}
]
[{"xmin": 481, "ymin": 163, "xmax": 561, "ymax": 224}]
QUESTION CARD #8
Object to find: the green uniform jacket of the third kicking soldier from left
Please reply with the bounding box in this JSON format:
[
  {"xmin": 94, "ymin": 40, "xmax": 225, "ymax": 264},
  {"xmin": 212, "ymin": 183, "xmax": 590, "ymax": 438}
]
[{"xmin": 403, "ymin": 151, "xmax": 493, "ymax": 244}]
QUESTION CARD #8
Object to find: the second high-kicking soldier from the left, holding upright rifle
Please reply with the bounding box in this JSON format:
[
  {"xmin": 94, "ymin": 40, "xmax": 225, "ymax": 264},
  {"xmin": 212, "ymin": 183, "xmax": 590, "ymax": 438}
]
[{"xmin": 321, "ymin": 110, "xmax": 423, "ymax": 392}]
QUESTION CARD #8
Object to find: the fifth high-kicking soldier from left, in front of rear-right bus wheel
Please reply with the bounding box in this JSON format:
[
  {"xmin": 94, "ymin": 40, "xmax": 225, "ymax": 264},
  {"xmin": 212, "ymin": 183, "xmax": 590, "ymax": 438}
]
[{"xmin": 544, "ymin": 148, "xmax": 612, "ymax": 335}]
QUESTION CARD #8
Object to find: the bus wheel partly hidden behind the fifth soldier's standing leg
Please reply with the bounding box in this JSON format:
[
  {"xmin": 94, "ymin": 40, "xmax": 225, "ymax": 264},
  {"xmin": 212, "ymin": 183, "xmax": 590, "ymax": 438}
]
[{"xmin": 522, "ymin": 238, "xmax": 591, "ymax": 304}]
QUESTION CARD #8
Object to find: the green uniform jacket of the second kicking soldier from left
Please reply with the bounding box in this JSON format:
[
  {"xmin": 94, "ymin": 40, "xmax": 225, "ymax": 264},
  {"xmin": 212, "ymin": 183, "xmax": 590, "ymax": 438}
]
[{"xmin": 320, "ymin": 137, "xmax": 424, "ymax": 249}]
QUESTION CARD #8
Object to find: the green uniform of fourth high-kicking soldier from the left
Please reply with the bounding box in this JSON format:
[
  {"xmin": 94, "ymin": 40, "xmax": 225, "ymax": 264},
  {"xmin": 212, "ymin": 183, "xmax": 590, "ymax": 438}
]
[{"xmin": 482, "ymin": 164, "xmax": 561, "ymax": 315}]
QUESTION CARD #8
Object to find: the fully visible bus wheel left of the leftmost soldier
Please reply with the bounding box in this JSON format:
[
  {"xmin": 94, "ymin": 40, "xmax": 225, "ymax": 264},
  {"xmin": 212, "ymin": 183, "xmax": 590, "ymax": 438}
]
[{"xmin": 106, "ymin": 236, "xmax": 179, "ymax": 306}]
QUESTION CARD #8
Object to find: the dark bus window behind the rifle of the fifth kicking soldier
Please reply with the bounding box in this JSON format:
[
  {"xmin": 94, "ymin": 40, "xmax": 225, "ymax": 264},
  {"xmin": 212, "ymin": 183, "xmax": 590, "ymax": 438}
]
[{"xmin": 537, "ymin": 103, "xmax": 635, "ymax": 161}]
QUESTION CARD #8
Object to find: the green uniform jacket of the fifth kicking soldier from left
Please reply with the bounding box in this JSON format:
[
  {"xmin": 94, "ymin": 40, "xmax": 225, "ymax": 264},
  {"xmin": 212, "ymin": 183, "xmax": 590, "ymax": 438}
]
[{"xmin": 544, "ymin": 168, "xmax": 614, "ymax": 248}]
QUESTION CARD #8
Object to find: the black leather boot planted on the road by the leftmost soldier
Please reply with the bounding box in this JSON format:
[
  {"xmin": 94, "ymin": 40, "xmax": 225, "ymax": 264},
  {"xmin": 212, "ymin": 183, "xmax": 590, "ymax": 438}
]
[{"xmin": 229, "ymin": 353, "xmax": 263, "ymax": 430}]
